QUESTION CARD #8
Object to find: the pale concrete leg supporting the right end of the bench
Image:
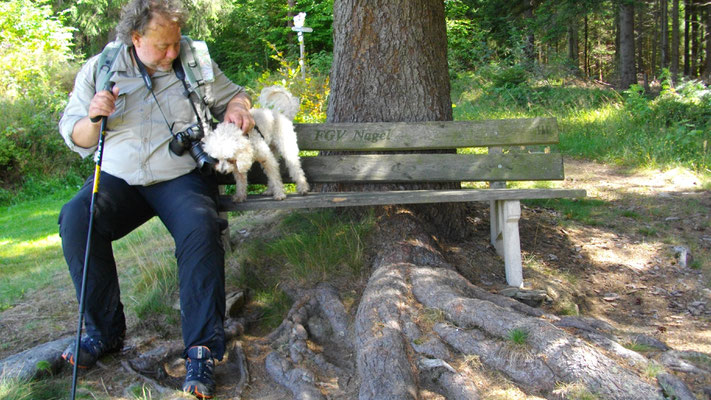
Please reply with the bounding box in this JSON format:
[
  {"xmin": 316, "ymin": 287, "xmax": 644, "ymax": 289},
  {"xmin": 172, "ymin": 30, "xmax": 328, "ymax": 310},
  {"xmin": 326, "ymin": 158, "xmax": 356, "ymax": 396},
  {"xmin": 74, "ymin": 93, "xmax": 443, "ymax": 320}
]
[{"xmin": 490, "ymin": 200, "xmax": 523, "ymax": 287}]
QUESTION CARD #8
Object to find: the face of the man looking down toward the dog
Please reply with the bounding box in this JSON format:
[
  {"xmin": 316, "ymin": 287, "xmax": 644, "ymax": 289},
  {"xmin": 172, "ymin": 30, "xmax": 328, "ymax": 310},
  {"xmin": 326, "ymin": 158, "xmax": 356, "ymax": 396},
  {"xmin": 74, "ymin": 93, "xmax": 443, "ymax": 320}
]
[{"xmin": 131, "ymin": 15, "xmax": 180, "ymax": 74}]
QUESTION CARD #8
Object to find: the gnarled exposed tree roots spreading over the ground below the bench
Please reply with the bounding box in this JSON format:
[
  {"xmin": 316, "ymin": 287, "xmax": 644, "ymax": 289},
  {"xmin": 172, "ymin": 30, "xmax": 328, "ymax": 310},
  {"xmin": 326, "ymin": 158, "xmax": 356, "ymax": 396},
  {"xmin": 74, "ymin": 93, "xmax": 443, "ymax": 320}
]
[{"xmin": 248, "ymin": 213, "xmax": 708, "ymax": 400}]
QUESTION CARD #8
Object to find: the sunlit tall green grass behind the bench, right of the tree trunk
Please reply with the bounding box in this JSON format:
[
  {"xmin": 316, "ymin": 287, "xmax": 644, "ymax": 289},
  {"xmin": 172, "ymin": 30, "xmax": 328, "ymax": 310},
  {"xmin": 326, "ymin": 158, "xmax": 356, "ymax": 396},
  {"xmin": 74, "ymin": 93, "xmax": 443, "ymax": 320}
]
[{"xmin": 452, "ymin": 73, "xmax": 711, "ymax": 177}]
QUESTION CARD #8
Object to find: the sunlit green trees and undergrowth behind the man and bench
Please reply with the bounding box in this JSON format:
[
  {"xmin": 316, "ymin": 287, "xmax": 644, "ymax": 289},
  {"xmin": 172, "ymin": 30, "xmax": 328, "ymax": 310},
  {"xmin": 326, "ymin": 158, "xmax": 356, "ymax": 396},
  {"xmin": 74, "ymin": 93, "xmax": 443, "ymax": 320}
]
[{"xmin": 0, "ymin": 0, "xmax": 711, "ymax": 205}]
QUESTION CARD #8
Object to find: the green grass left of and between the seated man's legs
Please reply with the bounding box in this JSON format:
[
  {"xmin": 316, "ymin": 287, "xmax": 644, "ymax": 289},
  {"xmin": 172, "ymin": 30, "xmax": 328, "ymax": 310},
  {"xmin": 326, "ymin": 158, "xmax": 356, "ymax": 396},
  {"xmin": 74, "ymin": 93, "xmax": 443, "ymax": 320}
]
[{"xmin": 0, "ymin": 190, "xmax": 184, "ymax": 330}]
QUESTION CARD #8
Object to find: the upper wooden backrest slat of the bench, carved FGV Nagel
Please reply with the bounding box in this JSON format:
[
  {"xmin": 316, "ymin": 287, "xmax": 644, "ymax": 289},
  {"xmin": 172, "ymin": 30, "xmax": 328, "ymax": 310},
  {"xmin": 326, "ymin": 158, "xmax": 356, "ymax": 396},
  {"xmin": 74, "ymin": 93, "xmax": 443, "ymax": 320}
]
[{"xmin": 295, "ymin": 118, "xmax": 558, "ymax": 151}]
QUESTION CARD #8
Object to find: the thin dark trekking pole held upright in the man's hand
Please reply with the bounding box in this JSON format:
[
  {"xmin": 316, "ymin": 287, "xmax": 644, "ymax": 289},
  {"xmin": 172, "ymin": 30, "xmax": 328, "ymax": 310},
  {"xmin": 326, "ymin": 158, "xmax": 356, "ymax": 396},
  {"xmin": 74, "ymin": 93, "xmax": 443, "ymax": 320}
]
[{"xmin": 72, "ymin": 82, "xmax": 114, "ymax": 400}]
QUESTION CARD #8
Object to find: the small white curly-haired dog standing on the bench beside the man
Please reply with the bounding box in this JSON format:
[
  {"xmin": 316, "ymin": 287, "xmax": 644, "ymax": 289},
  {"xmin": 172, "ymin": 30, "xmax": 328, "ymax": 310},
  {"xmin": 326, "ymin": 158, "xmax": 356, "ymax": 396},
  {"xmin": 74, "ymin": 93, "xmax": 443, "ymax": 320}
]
[{"xmin": 202, "ymin": 86, "xmax": 309, "ymax": 202}]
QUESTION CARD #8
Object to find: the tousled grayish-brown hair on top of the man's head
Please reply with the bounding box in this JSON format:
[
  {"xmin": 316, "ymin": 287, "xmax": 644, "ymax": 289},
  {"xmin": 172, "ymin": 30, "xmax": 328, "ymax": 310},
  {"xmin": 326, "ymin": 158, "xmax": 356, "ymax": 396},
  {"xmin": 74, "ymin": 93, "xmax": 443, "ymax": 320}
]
[{"xmin": 116, "ymin": 0, "xmax": 185, "ymax": 45}]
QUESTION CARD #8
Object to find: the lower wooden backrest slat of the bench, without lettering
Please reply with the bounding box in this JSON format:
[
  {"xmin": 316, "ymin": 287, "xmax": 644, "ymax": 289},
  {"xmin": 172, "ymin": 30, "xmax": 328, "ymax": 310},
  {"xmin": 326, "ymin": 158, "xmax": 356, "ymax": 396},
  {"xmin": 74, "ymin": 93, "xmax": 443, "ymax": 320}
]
[{"xmin": 220, "ymin": 153, "xmax": 564, "ymax": 184}]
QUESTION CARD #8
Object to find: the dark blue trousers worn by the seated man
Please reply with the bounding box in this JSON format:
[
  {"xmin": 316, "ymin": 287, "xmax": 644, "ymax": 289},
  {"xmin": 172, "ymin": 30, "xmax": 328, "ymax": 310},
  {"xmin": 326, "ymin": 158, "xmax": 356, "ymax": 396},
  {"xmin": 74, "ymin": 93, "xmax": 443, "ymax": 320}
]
[{"xmin": 59, "ymin": 172, "xmax": 226, "ymax": 360}]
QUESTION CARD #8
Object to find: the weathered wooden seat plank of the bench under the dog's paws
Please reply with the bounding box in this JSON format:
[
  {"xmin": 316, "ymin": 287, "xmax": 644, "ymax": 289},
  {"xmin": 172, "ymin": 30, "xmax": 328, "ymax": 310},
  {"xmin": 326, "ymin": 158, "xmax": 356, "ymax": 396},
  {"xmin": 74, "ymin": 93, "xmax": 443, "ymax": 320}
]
[{"xmin": 218, "ymin": 189, "xmax": 586, "ymax": 211}]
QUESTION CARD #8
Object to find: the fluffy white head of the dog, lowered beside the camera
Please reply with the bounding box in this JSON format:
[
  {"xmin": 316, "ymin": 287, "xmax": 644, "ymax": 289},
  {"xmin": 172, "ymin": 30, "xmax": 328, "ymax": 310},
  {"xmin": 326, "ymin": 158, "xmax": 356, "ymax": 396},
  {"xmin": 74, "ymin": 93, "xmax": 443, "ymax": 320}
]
[{"xmin": 202, "ymin": 122, "xmax": 253, "ymax": 174}]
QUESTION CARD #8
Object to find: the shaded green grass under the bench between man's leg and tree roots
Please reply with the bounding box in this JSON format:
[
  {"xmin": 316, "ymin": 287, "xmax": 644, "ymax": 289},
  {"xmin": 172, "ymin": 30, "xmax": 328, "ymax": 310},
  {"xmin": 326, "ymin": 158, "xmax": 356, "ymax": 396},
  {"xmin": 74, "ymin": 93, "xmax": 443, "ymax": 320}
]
[{"xmin": 235, "ymin": 210, "xmax": 374, "ymax": 329}]
